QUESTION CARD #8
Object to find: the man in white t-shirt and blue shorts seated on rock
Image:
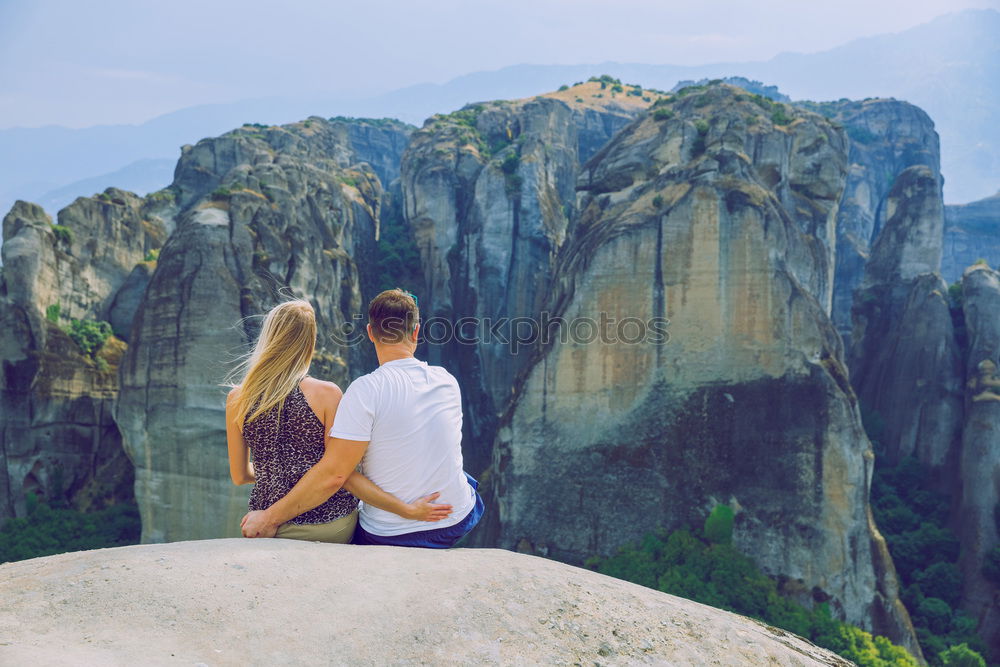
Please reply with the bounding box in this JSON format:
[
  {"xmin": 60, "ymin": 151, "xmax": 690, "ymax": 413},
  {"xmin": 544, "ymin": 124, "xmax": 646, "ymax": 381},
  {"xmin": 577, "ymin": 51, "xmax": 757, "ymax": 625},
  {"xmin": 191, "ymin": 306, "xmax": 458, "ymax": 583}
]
[{"xmin": 242, "ymin": 289, "xmax": 484, "ymax": 549}]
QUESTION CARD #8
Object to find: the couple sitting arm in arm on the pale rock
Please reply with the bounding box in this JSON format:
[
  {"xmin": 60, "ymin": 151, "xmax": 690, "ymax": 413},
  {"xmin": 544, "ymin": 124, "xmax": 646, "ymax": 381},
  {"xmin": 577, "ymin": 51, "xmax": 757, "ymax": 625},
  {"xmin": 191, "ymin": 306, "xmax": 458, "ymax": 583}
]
[{"xmin": 226, "ymin": 289, "xmax": 483, "ymax": 548}]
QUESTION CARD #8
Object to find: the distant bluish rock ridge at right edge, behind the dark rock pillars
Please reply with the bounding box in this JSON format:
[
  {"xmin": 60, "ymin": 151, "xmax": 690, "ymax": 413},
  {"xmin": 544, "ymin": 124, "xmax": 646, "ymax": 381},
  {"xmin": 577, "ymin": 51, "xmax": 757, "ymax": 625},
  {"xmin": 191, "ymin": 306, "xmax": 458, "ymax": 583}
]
[{"xmin": 941, "ymin": 192, "xmax": 1000, "ymax": 283}]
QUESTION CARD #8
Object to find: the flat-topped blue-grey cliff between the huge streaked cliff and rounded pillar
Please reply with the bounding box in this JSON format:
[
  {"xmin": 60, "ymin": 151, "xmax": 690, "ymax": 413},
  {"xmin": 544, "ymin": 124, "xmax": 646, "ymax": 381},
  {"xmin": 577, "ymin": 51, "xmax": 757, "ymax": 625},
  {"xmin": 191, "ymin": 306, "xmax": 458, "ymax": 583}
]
[{"xmin": 817, "ymin": 99, "xmax": 941, "ymax": 347}]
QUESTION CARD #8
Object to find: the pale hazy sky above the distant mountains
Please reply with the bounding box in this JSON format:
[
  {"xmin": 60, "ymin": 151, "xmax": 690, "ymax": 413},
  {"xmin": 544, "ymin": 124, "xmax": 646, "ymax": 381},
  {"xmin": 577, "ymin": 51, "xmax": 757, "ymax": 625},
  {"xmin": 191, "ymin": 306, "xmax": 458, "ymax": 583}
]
[{"xmin": 0, "ymin": 0, "xmax": 1000, "ymax": 128}]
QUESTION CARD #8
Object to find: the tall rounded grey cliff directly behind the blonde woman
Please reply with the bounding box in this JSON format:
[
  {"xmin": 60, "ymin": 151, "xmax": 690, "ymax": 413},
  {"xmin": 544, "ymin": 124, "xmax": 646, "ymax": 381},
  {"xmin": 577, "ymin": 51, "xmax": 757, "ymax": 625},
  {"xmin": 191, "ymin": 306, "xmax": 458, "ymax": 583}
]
[{"xmin": 116, "ymin": 118, "xmax": 405, "ymax": 542}]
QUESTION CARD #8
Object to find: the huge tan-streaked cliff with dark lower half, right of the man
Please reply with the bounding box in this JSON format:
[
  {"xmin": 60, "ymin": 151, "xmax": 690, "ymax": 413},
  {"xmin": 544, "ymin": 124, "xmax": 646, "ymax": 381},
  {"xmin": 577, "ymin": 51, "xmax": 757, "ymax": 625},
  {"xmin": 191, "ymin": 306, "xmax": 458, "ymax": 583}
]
[{"xmin": 472, "ymin": 85, "xmax": 915, "ymax": 645}]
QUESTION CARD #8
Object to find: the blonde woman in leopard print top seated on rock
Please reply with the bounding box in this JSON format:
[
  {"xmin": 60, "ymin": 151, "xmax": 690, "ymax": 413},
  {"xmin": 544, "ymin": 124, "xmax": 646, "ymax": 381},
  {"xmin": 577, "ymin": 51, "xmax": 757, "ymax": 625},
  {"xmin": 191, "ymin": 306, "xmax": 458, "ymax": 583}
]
[{"xmin": 226, "ymin": 300, "xmax": 451, "ymax": 543}]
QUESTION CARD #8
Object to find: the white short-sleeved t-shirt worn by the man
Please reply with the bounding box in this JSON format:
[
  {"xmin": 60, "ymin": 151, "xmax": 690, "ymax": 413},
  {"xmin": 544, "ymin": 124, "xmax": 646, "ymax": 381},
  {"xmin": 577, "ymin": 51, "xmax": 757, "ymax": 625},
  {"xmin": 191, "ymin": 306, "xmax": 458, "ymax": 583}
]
[{"xmin": 330, "ymin": 357, "xmax": 476, "ymax": 536}]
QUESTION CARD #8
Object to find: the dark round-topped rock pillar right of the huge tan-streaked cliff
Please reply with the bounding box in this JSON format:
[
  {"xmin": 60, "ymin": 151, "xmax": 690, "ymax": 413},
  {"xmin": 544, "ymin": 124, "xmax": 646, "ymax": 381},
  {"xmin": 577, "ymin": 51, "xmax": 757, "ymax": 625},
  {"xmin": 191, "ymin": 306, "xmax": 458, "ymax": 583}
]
[{"xmin": 848, "ymin": 165, "xmax": 963, "ymax": 472}]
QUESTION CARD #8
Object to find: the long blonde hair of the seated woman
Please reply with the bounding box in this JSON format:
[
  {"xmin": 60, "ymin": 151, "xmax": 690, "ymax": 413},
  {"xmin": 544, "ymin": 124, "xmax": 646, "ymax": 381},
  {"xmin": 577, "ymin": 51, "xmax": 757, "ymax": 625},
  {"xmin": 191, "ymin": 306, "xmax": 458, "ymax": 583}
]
[{"xmin": 228, "ymin": 300, "xmax": 316, "ymax": 428}]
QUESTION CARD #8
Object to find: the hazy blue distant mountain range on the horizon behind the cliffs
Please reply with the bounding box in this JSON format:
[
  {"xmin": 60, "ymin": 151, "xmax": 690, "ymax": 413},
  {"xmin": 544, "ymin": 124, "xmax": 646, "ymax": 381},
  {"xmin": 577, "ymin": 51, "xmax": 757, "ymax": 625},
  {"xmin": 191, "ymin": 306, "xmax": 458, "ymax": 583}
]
[{"xmin": 0, "ymin": 10, "xmax": 1000, "ymax": 213}]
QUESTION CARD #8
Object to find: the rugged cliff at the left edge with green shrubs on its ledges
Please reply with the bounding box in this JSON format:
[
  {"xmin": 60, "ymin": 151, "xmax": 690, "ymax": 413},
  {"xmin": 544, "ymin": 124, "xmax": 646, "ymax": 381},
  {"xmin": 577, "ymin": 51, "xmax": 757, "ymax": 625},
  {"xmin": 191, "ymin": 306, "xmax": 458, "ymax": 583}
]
[{"xmin": 0, "ymin": 189, "xmax": 165, "ymax": 519}]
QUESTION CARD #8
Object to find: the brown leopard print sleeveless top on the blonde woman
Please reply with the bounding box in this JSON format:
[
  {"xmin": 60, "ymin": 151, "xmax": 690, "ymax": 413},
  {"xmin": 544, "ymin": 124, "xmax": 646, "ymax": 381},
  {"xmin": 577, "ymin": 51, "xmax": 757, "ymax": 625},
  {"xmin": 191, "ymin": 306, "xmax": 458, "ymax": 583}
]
[{"xmin": 243, "ymin": 386, "xmax": 358, "ymax": 524}]
